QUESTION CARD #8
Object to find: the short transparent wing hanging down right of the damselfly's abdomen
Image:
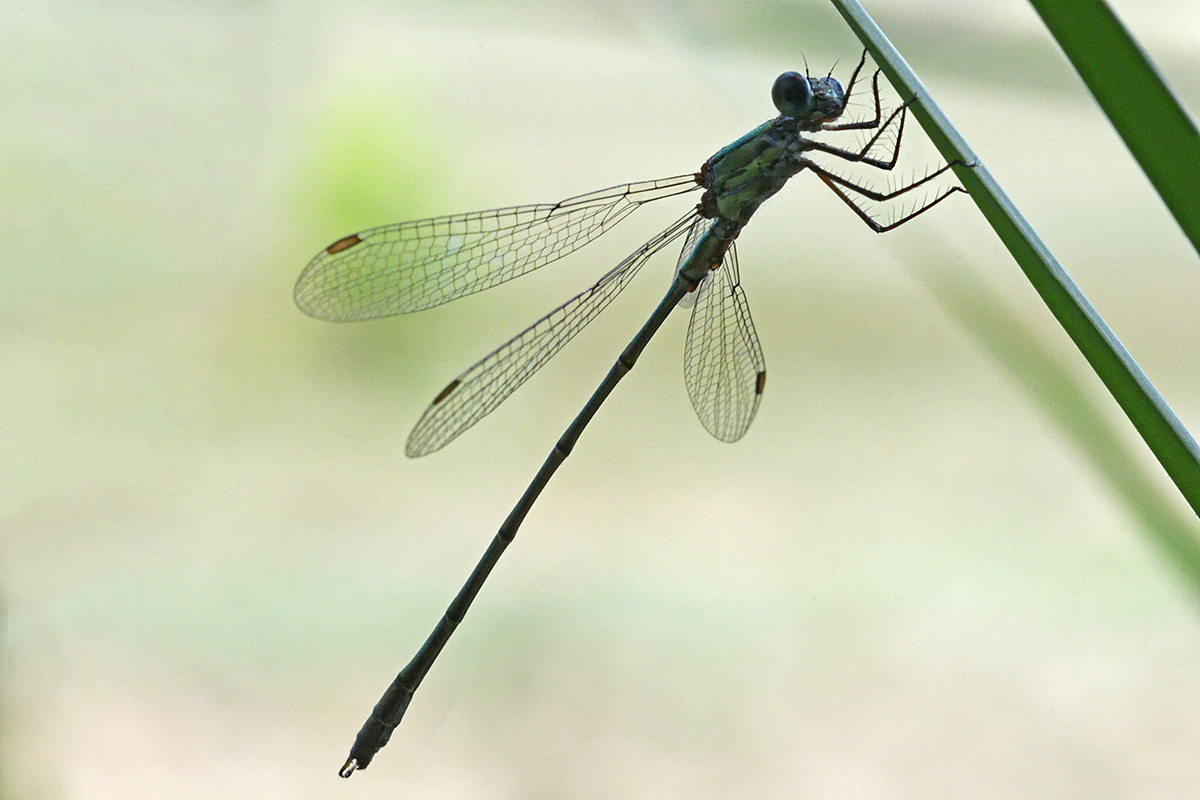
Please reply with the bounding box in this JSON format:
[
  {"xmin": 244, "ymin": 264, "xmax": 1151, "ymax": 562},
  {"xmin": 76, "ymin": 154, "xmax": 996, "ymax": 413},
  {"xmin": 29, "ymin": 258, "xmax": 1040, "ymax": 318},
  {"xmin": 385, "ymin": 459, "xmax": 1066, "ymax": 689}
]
[{"xmin": 683, "ymin": 243, "xmax": 767, "ymax": 441}]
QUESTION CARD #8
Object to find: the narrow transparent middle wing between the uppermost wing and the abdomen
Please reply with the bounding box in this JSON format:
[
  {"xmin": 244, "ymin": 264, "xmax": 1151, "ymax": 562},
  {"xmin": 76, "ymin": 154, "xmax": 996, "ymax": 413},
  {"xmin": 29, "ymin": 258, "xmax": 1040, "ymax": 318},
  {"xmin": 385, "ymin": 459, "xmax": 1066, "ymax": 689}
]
[{"xmin": 404, "ymin": 211, "xmax": 696, "ymax": 458}]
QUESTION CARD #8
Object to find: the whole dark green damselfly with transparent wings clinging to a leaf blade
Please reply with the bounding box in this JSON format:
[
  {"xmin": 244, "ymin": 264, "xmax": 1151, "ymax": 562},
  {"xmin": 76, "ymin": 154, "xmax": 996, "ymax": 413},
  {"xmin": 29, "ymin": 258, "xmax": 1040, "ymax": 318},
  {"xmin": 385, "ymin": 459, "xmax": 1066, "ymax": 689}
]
[{"xmin": 295, "ymin": 53, "xmax": 962, "ymax": 777}]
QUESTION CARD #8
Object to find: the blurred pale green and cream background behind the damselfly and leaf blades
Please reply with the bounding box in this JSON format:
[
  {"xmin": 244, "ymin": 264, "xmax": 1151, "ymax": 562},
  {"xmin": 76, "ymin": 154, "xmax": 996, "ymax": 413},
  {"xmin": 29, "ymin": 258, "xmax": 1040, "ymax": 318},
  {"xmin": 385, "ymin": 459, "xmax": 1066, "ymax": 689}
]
[{"xmin": 7, "ymin": 0, "xmax": 1200, "ymax": 800}]
